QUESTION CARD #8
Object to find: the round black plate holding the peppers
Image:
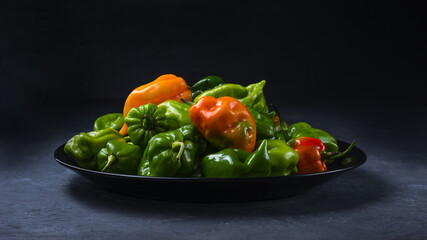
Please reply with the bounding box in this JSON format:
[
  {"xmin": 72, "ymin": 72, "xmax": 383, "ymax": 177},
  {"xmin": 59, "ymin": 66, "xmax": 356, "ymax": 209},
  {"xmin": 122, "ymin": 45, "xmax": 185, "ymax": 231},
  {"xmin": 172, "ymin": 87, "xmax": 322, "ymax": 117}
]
[{"xmin": 54, "ymin": 141, "xmax": 366, "ymax": 202}]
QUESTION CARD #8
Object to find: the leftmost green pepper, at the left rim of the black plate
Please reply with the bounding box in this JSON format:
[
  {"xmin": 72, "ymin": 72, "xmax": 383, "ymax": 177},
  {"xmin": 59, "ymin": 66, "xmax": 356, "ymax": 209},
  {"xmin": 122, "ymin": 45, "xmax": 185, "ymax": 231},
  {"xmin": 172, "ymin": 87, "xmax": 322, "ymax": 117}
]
[{"xmin": 64, "ymin": 128, "xmax": 126, "ymax": 170}]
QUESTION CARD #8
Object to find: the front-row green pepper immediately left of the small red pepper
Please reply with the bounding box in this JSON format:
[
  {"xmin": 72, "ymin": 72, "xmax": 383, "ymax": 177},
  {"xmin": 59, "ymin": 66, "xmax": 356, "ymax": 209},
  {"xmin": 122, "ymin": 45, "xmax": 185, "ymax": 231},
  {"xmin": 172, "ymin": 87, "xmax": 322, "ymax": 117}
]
[{"xmin": 267, "ymin": 139, "xmax": 299, "ymax": 176}]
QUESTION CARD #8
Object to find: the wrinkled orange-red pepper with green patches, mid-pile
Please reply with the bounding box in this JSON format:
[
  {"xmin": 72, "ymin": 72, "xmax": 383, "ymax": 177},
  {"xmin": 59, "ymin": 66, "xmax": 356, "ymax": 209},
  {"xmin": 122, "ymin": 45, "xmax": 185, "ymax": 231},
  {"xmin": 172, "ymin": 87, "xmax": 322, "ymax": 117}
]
[{"xmin": 189, "ymin": 96, "xmax": 256, "ymax": 152}]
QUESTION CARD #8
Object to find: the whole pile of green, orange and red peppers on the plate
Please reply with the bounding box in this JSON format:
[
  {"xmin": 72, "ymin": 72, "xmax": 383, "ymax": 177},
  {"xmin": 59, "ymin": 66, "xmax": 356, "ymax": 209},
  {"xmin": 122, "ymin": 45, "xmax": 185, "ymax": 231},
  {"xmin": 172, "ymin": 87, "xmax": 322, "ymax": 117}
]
[{"xmin": 64, "ymin": 74, "xmax": 354, "ymax": 178}]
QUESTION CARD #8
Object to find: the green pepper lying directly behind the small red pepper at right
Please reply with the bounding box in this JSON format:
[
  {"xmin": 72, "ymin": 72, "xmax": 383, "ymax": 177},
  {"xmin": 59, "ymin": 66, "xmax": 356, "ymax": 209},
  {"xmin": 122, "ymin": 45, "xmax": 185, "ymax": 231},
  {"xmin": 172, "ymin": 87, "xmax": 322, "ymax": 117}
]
[{"xmin": 288, "ymin": 122, "xmax": 339, "ymax": 152}]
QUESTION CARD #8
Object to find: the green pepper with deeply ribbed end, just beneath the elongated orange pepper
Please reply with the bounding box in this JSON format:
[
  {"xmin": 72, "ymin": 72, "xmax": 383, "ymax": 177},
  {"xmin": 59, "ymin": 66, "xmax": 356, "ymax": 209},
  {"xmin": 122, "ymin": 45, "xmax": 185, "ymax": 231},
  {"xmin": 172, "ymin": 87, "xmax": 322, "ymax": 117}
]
[{"xmin": 125, "ymin": 100, "xmax": 191, "ymax": 149}]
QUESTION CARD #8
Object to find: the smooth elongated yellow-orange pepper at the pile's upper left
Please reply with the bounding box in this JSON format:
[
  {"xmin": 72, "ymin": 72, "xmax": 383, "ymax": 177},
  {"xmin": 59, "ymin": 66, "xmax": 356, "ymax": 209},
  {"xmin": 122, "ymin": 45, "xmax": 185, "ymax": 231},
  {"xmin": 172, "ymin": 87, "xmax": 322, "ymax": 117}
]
[{"xmin": 120, "ymin": 74, "xmax": 192, "ymax": 136}]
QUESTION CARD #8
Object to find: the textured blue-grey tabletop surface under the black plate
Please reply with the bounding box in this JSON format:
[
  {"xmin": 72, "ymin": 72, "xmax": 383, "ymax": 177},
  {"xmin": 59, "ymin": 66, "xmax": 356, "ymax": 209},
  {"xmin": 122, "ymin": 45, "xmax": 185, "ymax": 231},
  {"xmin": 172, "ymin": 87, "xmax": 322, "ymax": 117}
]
[{"xmin": 0, "ymin": 102, "xmax": 427, "ymax": 240}]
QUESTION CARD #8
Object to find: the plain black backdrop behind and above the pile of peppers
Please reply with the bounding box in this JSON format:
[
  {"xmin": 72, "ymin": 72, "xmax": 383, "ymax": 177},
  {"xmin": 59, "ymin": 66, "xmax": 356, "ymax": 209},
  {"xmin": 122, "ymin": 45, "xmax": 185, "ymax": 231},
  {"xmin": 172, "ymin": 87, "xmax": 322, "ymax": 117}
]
[{"xmin": 0, "ymin": 0, "xmax": 427, "ymax": 107}]
